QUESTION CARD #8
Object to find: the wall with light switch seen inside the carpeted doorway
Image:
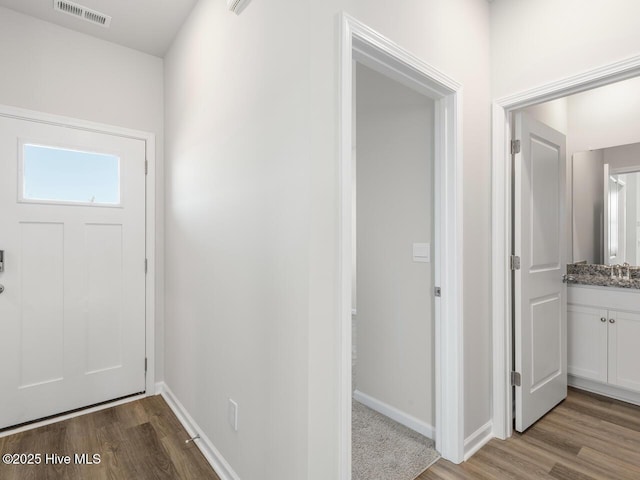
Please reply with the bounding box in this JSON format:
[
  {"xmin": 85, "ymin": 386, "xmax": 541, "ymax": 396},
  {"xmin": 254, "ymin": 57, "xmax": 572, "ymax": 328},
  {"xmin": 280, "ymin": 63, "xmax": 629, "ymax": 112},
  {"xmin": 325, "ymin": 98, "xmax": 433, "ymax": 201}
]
[{"xmin": 355, "ymin": 65, "xmax": 435, "ymax": 426}]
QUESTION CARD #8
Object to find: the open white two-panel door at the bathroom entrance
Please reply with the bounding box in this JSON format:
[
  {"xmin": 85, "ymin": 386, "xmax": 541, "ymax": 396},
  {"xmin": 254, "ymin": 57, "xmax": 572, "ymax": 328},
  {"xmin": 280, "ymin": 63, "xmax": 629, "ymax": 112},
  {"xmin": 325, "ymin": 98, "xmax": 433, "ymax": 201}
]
[{"xmin": 514, "ymin": 113, "xmax": 567, "ymax": 432}]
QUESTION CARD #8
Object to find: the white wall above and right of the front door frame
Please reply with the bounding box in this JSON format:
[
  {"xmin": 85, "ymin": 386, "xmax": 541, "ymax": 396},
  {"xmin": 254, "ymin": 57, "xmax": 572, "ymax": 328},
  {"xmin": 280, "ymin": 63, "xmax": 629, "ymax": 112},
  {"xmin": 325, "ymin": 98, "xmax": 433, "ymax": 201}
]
[{"xmin": 0, "ymin": 7, "xmax": 164, "ymax": 379}]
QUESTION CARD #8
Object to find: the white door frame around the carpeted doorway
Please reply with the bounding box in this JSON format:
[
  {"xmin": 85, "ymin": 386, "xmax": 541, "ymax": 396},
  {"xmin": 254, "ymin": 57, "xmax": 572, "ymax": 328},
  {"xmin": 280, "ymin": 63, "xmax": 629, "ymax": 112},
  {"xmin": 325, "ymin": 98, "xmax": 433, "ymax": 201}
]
[{"xmin": 338, "ymin": 13, "xmax": 464, "ymax": 480}]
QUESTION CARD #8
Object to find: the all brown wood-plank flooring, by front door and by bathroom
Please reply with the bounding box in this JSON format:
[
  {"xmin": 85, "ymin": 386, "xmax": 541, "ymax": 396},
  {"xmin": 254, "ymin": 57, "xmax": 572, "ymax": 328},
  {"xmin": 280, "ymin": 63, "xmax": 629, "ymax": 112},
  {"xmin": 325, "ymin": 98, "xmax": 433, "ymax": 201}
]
[{"xmin": 0, "ymin": 389, "xmax": 640, "ymax": 480}]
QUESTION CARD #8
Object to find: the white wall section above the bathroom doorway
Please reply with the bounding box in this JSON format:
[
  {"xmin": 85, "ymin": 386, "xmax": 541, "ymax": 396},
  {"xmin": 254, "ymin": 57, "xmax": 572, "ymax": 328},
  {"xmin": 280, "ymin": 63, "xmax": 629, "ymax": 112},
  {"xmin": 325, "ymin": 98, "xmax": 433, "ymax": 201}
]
[{"xmin": 491, "ymin": 0, "xmax": 640, "ymax": 98}]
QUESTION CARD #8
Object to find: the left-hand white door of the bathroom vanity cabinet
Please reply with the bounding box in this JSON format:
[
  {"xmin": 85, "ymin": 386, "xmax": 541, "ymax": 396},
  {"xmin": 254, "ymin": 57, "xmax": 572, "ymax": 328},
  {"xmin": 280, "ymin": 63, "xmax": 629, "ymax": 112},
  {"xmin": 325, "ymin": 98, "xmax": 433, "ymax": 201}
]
[{"xmin": 567, "ymin": 304, "xmax": 608, "ymax": 382}]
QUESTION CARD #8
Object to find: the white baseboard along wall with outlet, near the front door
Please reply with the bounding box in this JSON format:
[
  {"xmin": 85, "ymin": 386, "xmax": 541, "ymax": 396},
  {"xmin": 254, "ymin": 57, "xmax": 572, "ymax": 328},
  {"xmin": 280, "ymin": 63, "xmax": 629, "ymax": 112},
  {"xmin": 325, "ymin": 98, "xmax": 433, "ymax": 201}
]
[{"xmin": 156, "ymin": 382, "xmax": 240, "ymax": 480}]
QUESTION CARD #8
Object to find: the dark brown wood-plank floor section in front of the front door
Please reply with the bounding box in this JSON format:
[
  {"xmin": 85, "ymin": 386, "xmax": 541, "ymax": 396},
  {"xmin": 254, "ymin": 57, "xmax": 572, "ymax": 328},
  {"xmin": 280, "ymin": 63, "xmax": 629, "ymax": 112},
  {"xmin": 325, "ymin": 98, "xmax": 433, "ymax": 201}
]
[{"xmin": 0, "ymin": 395, "xmax": 220, "ymax": 480}]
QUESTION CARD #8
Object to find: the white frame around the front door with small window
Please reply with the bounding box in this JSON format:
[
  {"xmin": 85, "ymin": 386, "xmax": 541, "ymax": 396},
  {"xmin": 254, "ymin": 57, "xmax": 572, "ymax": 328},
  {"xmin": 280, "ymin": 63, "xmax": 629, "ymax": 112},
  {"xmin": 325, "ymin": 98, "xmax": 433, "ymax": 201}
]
[{"xmin": 0, "ymin": 105, "xmax": 156, "ymax": 396}]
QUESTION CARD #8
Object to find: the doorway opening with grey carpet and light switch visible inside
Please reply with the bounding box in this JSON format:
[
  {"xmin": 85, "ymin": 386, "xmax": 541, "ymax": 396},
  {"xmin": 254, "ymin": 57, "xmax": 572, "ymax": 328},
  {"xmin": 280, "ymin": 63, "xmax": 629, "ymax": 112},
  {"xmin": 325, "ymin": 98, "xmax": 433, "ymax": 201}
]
[{"xmin": 352, "ymin": 62, "xmax": 439, "ymax": 480}]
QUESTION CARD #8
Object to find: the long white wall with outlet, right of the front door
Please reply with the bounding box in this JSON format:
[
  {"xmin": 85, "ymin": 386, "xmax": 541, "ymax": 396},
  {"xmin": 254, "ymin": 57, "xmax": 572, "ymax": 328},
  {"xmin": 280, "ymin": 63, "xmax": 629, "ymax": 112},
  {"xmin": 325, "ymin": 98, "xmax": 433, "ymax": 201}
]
[{"xmin": 165, "ymin": 0, "xmax": 308, "ymax": 480}]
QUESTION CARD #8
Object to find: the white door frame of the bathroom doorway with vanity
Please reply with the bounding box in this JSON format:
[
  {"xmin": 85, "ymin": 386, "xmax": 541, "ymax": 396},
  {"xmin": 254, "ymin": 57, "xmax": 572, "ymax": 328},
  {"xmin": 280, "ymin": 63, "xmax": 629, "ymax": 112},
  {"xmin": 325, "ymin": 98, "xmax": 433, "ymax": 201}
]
[{"xmin": 491, "ymin": 56, "xmax": 640, "ymax": 439}]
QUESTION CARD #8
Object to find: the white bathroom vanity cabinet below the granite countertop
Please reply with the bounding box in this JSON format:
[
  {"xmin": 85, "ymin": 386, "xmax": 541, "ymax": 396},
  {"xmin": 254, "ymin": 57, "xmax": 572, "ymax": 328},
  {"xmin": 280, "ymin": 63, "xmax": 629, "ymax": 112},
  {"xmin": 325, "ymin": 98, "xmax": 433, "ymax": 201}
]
[{"xmin": 567, "ymin": 286, "xmax": 640, "ymax": 400}]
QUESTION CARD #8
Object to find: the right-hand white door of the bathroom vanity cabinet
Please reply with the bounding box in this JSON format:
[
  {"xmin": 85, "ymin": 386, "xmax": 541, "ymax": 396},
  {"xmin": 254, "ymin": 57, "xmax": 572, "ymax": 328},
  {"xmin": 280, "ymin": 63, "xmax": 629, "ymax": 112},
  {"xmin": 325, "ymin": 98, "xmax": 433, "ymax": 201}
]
[{"xmin": 609, "ymin": 310, "xmax": 640, "ymax": 391}]
